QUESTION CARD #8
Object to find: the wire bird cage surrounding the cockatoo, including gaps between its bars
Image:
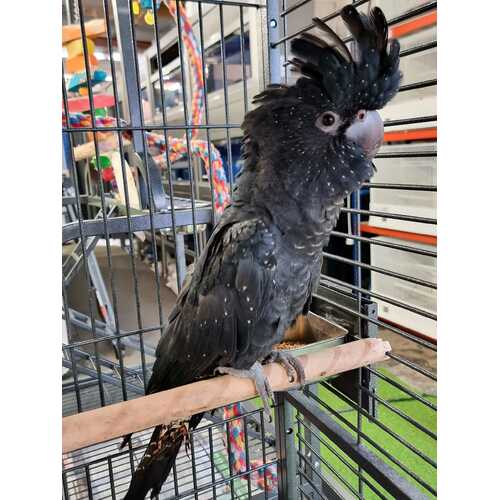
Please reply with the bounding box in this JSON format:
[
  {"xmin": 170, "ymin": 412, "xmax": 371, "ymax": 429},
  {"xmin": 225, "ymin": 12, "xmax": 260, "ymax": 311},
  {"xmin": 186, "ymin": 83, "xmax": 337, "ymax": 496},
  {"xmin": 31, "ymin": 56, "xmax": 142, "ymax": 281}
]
[{"xmin": 62, "ymin": 0, "xmax": 437, "ymax": 499}]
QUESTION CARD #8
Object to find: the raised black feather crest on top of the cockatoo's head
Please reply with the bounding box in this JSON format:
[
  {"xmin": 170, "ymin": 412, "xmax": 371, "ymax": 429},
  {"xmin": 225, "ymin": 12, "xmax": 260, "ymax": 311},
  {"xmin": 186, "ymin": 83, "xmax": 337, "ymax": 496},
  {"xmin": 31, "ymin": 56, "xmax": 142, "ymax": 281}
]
[{"xmin": 291, "ymin": 5, "xmax": 401, "ymax": 117}]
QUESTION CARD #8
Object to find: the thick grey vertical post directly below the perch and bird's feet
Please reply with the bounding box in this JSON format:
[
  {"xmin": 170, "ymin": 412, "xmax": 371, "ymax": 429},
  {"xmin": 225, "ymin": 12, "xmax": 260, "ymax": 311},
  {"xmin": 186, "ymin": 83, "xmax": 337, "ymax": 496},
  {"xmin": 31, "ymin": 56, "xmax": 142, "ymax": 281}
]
[{"xmin": 275, "ymin": 392, "xmax": 298, "ymax": 500}]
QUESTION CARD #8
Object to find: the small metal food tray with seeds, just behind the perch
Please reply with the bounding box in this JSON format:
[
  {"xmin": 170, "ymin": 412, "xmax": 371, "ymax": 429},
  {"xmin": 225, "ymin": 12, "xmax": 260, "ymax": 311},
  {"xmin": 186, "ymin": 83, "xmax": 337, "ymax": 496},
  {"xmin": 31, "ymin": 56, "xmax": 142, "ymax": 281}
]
[{"xmin": 274, "ymin": 312, "xmax": 348, "ymax": 356}]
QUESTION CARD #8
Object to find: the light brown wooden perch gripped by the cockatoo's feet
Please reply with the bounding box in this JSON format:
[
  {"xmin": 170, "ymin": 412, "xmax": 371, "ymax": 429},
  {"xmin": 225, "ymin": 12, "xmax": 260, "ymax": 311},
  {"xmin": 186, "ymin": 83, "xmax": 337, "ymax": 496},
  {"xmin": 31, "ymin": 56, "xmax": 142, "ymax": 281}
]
[{"xmin": 62, "ymin": 338, "xmax": 391, "ymax": 453}]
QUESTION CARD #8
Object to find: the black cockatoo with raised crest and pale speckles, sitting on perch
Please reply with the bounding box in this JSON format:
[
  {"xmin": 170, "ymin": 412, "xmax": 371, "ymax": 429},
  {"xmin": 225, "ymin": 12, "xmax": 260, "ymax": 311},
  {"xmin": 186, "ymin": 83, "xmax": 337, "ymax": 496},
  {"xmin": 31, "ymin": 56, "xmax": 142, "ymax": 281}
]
[{"xmin": 124, "ymin": 6, "xmax": 401, "ymax": 500}]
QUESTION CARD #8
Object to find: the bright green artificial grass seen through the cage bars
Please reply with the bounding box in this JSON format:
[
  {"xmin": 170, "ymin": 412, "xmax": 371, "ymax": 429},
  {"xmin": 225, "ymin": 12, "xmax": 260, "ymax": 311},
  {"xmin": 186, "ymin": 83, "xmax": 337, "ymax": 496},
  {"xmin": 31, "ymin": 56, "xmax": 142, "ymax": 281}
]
[{"xmin": 318, "ymin": 369, "xmax": 437, "ymax": 499}]
